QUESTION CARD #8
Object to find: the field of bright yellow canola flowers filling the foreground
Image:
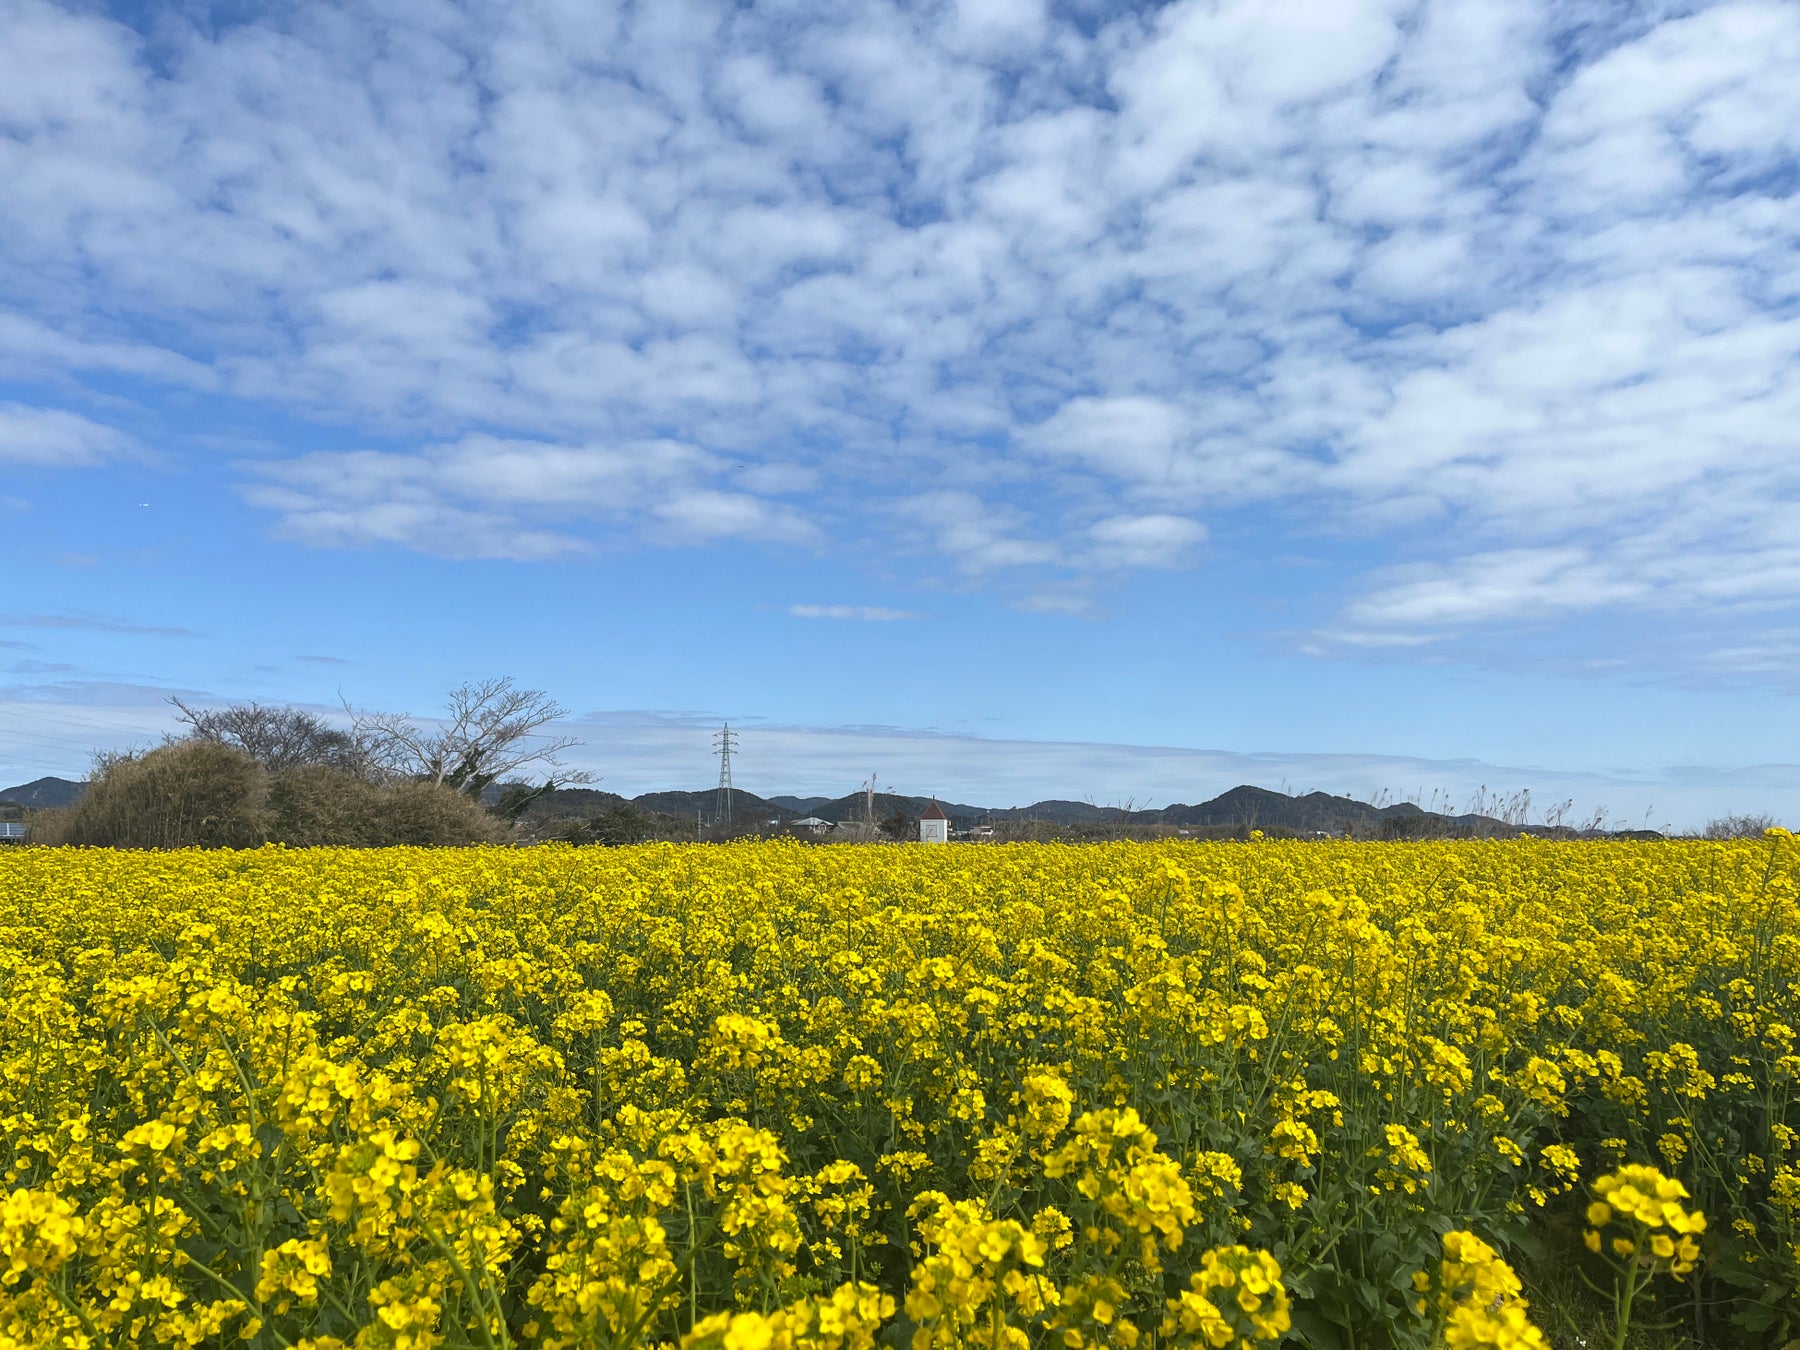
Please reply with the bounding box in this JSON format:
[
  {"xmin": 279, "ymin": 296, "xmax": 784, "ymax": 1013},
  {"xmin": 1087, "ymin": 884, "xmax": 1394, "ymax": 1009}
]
[{"xmin": 0, "ymin": 832, "xmax": 1800, "ymax": 1350}]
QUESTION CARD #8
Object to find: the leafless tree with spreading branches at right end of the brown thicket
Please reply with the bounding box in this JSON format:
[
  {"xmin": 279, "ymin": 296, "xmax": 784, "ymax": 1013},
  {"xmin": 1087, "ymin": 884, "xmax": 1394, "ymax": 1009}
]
[{"xmin": 344, "ymin": 675, "xmax": 592, "ymax": 808}]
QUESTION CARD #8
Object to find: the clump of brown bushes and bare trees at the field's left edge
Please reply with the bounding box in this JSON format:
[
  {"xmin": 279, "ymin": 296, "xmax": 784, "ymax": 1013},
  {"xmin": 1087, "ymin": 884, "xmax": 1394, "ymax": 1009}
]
[{"xmin": 32, "ymin": 679, "xmax": 587, "ymax": 848}]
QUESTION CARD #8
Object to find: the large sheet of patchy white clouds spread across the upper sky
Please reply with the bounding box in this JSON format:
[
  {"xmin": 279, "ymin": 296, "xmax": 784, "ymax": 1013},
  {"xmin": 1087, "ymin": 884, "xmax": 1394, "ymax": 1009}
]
[{"xmin": 0, "ymin": 0, "xmax": 1800, "ymax": 676}]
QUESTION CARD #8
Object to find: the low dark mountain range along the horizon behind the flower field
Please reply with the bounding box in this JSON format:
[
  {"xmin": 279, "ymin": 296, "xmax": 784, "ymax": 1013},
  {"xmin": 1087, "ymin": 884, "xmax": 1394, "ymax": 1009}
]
[{"xmin": 0, "ymin": 778, "xmax": 1641, "ymax": 835}]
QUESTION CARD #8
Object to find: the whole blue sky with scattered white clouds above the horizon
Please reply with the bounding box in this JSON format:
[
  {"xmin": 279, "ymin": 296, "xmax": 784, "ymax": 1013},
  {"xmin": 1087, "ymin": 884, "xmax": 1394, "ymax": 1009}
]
[{"xmin": 0, "ymin": 0, "xmax": 1800, "ymax": 823}]
